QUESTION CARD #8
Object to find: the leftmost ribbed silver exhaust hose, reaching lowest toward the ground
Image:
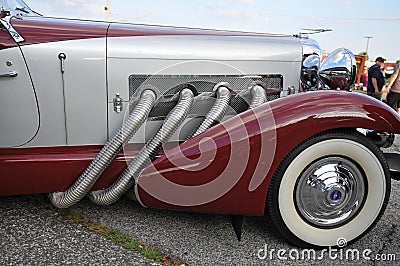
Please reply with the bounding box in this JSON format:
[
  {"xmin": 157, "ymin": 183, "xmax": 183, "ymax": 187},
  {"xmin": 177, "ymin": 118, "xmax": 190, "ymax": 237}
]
[{"xmin": 49, "ymin": 89, "xmax": 156, "ymax": 208}]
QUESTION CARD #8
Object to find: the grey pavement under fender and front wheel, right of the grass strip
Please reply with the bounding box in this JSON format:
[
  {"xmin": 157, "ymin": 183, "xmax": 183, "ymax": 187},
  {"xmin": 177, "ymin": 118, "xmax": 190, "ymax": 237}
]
[{"xmin": 72, "ymin": 181, "xmax": 400, "ymax": 265}]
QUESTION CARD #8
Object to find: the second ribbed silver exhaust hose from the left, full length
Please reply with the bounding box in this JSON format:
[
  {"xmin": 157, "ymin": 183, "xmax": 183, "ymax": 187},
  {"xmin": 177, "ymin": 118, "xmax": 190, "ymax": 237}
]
[{"xmin": 89, "ymin": 88, "xmax": 194, "ymax": 205}]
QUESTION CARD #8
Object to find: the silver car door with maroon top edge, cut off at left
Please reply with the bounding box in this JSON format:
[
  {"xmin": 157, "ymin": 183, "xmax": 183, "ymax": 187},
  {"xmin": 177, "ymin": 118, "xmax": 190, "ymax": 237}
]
[{"xmin": 0, "ymin": 27, "xmax": 40, "ymax": 147}]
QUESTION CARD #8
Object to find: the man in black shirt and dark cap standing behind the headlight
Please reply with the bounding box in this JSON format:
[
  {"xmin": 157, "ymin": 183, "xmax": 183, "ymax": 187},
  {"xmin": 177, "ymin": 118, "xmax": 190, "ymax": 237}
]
[{"xmin": 367, "ymin": 56, "xmax": 385, "ymax": 100}]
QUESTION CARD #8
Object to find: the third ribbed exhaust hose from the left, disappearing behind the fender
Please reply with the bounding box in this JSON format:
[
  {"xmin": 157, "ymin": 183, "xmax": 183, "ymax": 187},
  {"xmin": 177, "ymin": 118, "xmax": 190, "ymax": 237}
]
[{"xmin": 189, "ymin": 84, "xmax": 231, "ymax": 138}]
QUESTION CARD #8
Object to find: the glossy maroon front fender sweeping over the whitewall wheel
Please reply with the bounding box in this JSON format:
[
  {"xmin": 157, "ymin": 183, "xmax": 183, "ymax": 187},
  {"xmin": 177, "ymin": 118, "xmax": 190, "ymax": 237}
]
[{"xmin": 136, "ymin": 91, "xmax": 400, "ymax": 215}]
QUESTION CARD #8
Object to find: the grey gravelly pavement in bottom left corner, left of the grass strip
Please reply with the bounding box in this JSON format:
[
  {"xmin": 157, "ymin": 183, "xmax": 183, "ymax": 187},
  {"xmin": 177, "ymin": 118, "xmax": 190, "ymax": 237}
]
[{"xmin": 0, "ymin": 196, "xmax": 151, "ymax": 265}]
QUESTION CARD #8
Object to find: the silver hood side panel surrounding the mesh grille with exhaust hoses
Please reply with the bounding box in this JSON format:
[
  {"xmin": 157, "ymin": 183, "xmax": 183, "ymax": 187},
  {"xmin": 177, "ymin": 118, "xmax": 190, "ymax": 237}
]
[{"xmin": 107, "ymin": 36, "xmax": 302, "ymax": 142}]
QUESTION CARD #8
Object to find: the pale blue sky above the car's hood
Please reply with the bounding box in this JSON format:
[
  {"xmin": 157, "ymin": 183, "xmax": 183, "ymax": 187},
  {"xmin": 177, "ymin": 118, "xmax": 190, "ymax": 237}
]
[{"xmin": 26, "ymin": 0, "xmax": 400, "ymax": 61}]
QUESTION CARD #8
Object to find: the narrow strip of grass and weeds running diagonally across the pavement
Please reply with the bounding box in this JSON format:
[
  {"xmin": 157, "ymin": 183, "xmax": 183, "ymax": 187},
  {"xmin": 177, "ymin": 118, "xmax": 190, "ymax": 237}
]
[{"xmin": 26, "ymin": 195, "xmax": 185, "ymax": 266}]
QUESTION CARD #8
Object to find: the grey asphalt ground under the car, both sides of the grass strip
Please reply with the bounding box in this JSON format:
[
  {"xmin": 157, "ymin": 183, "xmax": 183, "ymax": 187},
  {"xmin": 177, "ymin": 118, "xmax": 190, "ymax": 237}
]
[{"xmin": 0, "ymin": 137, "xmax": 400, "ymax": 266}]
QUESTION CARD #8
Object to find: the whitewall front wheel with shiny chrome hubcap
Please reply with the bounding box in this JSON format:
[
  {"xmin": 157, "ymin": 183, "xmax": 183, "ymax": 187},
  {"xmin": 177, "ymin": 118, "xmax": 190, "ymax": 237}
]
[{"xmin": 267, "ymin": 130, "xmax": 391, "ymax": 248}]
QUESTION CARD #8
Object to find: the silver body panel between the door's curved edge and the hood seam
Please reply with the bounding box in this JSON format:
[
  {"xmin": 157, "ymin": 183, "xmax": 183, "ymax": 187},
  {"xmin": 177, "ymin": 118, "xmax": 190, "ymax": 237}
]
[{"xmin": 18, "ymin": 39, "xmax": 107, "ymax": 146}]
